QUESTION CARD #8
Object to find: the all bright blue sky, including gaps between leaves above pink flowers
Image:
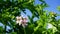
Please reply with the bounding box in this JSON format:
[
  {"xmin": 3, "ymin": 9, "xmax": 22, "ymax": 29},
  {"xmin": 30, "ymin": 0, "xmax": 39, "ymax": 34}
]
[{"xmin": 22, "ymin": 0, "xmax": 60, "ymax": 20}]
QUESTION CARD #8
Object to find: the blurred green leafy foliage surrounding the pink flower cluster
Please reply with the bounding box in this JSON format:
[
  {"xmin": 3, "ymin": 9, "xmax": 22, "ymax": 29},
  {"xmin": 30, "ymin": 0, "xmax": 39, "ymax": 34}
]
[{"xmin": 0, "ymin": 0, "xmax": 60, "ymax": 34}]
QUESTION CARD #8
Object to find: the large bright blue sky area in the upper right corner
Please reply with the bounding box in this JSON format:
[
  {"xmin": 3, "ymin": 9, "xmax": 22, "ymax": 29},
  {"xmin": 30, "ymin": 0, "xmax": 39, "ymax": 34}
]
[{"xmin": 45, "ymin": 0, "xmax": 60, "ymax": 19}]
